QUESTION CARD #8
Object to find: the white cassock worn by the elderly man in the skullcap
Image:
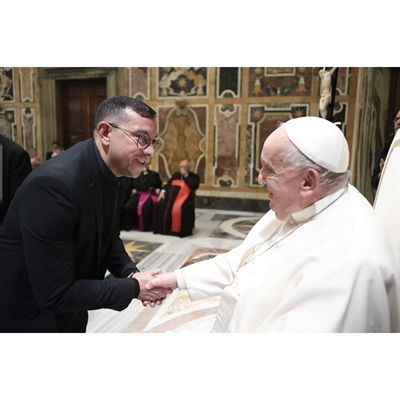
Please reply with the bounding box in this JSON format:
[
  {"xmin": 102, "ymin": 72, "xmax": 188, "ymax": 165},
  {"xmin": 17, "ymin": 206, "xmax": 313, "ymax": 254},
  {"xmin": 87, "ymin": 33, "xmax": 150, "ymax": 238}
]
[{"xmin": 175, "ymin": 185, "xmax": 400, "ymax": 333}]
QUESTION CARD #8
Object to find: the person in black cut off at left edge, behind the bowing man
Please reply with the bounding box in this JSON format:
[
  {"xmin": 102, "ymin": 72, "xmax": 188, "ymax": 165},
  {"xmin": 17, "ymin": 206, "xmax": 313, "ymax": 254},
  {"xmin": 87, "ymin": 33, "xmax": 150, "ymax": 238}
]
[{"xmin": 0, "ymin": 134, "xmax": 32, "ymax": 225}]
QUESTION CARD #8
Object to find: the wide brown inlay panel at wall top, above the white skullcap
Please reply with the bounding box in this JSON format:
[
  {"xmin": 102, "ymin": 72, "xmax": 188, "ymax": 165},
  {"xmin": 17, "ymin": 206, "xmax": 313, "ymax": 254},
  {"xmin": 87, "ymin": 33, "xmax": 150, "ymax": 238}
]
[{"xmin": 248, "ymin": 67, "xmax": 313, "ymax": 96}]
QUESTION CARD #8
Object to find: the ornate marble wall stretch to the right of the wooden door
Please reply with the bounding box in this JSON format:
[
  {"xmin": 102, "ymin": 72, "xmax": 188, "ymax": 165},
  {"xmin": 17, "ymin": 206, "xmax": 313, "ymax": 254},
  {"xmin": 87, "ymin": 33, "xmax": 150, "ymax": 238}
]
[{"xmin": 129, "ymin": 67, "xmax": 358, "ymax": 204}]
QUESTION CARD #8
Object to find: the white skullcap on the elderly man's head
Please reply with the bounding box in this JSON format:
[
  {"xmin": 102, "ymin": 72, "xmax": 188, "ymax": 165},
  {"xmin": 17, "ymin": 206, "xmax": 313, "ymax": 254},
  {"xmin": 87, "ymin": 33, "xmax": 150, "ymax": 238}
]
[{"xmin": 283, "ymin": 117, "xmax": 349, "ymax": 173}]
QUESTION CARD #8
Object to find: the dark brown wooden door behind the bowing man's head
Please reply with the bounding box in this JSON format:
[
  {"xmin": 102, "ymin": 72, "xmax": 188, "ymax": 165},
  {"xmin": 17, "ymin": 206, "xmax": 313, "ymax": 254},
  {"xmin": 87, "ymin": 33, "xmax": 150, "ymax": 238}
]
[{"xmin": 60, "ymin": 79, "xmax": 107, "ymax": 149}]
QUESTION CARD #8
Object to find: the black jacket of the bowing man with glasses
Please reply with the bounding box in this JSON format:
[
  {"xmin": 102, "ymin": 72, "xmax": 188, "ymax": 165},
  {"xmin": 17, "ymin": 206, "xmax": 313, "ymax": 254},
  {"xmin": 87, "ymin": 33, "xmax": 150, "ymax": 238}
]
[{"xmin": 0, "ymin": 139, "xmax": 139, "ymax": 332}]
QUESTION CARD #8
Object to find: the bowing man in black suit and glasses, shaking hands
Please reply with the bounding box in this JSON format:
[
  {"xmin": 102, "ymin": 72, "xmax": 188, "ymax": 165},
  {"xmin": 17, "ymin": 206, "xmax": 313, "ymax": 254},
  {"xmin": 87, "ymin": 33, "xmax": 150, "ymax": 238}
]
[{"xmin": 0, "ymin": 96, "xmax": 170, "ymax": 332}]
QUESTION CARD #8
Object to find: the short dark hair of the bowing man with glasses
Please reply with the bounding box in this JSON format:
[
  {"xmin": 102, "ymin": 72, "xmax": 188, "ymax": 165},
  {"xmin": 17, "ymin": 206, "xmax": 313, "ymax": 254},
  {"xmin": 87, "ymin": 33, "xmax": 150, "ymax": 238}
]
[{"xmin": 94, "ymin": 96, "xmax": 157, "ymax": 127}]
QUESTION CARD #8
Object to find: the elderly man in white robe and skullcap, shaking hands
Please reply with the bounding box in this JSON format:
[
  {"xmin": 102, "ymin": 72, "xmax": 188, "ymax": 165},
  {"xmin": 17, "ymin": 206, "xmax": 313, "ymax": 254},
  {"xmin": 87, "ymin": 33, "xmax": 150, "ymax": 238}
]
[{"xmin": 147, "ymin": 117, "xmax": 400, "ymax": 333}]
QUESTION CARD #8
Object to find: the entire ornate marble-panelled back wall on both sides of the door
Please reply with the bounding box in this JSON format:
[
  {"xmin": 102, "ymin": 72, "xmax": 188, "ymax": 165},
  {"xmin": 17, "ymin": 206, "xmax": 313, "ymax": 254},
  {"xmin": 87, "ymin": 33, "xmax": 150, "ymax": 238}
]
[{"xmin": 0, "ymin": 67, "xmax": 388, "ymax": 210}]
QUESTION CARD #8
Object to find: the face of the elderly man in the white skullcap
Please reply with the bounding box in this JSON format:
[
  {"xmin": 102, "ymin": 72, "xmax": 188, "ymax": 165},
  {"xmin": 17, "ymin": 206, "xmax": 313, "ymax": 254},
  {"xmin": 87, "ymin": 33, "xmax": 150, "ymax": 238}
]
[{"xmin": 258, "ymin": 126, "xmax": 303, "ymax": 221}]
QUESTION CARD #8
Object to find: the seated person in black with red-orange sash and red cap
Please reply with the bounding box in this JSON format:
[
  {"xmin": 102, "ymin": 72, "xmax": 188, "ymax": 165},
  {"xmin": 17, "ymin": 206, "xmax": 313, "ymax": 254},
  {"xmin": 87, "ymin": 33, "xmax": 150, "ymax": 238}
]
[{"xmin": 154, "ymin": 160, "xmax": 200, "ymax": 237}]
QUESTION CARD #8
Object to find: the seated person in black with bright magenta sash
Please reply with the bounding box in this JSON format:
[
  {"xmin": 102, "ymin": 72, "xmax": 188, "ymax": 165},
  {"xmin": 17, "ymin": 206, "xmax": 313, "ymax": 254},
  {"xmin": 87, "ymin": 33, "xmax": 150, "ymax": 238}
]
[{"xmin": 120, "ymin": 164, "xmax": 162, "ymax": 232}]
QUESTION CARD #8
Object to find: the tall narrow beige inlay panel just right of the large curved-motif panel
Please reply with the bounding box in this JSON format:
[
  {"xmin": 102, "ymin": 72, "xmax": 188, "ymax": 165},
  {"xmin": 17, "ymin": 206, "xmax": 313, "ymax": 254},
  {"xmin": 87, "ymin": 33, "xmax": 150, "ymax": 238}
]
[{"xmin": 214, "ymin": 104, "xmax": 241, "ymax": 186}]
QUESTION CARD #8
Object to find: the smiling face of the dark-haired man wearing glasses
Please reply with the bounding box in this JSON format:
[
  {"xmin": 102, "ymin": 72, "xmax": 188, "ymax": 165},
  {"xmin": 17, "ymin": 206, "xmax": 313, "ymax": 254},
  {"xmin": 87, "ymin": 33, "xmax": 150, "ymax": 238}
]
[{"xmin": 98, "ymin": 108, "xmax": 157, "ymax": 178}]
